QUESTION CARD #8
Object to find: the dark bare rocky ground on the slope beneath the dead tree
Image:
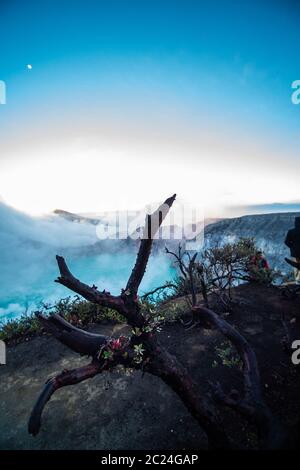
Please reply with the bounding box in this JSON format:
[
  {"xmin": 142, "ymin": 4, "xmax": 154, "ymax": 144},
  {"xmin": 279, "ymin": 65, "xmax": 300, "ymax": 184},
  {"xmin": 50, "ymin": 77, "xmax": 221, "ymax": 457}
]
[{"xmin": 0, "ymin": 285, "xmax": 300, "ymax": 450}]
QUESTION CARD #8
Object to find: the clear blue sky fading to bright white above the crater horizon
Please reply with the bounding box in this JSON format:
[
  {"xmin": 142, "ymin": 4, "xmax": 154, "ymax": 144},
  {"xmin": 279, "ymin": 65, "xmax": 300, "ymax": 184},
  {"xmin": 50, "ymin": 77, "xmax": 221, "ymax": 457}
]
[{"xmin": 0, "ymin": 0, "xmax": 300, "ymax": 215}]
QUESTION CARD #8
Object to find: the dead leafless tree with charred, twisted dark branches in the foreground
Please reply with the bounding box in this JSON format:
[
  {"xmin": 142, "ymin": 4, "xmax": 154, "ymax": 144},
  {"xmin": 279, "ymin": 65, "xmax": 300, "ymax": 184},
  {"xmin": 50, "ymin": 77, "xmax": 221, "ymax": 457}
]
[{"xmin": 28, "ymin": 195, "xmax": 298, "ymax": 449}]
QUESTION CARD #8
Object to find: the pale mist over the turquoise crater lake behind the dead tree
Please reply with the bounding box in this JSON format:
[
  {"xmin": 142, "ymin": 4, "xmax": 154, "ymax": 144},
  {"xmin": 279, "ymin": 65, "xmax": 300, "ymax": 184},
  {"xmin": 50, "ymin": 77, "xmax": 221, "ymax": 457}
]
[{"xmin": 0, "ymin": 203, "xmax": 172, "ymax": 320}]
